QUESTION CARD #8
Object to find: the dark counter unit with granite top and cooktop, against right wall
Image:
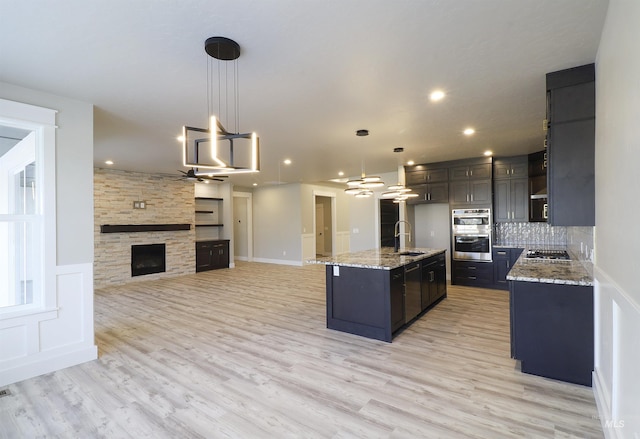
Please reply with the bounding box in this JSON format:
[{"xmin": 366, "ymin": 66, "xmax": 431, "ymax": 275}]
[{"xmin": 507, "ymin": 249, "xmax": 594, "ymax": 386}]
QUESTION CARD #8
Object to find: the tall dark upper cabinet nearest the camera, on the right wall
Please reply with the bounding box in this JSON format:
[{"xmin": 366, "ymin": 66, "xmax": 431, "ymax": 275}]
[{"xmin": 547, "ymin": 64, "xmax": 595, "ymax": 226}]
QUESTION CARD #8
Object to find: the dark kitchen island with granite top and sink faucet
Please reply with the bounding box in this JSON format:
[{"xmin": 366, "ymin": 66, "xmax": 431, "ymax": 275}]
[{"xmin": 309, "ymin": 247, "xmax": 447, "ymax": 342}]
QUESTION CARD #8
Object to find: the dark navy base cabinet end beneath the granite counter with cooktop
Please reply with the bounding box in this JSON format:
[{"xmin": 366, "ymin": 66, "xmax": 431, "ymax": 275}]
[{"xmin": 510, "ymin": 281, "xmax": 594, "ymax": 386}]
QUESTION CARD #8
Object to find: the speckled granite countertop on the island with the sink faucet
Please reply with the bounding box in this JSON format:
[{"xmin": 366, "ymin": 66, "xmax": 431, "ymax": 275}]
[{"xmin": 307, "ymin": 247, "xmax": 446, "ymax": 270}]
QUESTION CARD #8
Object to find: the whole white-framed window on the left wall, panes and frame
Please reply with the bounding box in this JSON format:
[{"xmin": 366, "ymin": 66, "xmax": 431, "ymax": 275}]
[{"xmin": 0, "ymin": 99, "xmax": 55, "ymax": 315}]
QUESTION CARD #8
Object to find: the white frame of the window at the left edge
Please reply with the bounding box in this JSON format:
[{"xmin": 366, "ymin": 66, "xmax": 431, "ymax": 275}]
[{"xmin": 0, "ymin": 99, "xmax": 57, "ymax": 320}]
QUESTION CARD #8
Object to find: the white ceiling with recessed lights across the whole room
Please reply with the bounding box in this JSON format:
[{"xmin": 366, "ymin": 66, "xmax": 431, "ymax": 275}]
[{"xmin": 0, "ymin": 0, "xmax": 608, "ymax": 185}]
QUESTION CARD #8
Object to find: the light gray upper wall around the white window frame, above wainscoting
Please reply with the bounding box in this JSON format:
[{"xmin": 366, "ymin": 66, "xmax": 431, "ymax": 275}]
[{"xmin": 0, "ymin": 82, "xmax": 93, "ymax": 265}]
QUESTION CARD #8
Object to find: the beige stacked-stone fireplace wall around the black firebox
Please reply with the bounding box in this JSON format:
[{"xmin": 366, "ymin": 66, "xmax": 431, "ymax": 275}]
[{"xmin": 94, "ymin": 168, "xmax": 196, "ymax": 288}]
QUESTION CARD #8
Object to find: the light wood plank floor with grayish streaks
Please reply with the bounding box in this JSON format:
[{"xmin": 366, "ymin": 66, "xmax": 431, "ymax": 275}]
[{"xmin": 0, "ymin": 262, "xmax": 603, "ymax": 438}]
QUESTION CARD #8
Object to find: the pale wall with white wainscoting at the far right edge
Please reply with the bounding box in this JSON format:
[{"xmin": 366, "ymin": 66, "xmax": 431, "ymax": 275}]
[{"xmin": 594, "ymin": 0, "xmax": 640, "ymax": 438}]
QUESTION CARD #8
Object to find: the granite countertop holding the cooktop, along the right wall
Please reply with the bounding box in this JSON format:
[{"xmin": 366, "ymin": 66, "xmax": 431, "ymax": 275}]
[{"xmin": 507, "ymin": 247, "xmax": 593, "ymax": 286}]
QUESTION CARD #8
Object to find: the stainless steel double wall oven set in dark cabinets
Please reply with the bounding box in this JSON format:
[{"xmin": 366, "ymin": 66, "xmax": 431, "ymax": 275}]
[{"xmin": 451, "ymin": 209, "xmax": 491, "ymax": 262}]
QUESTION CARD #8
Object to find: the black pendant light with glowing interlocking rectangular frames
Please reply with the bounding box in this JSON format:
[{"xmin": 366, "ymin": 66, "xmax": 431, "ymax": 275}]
[{"xmin": 181, "ymin": 37, "xmax": 260, "ymax": 175}]
